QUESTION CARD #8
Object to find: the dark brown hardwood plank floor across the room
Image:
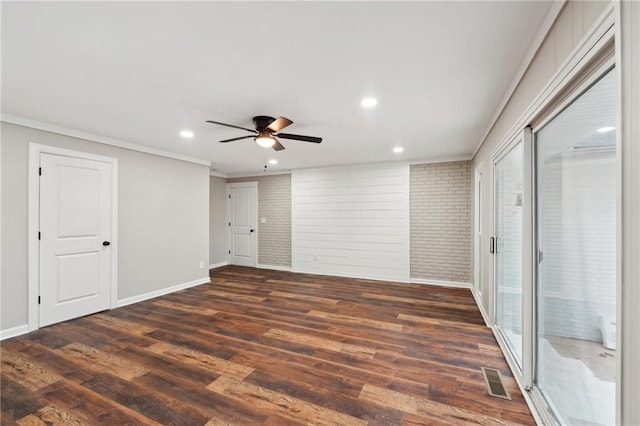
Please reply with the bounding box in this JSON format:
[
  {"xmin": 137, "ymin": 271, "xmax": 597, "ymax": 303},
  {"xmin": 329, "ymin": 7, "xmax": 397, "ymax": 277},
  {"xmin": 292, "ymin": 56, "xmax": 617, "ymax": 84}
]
[{"xmin": 0, "ymin": 266, "xmax": 534, "ymax": 425}]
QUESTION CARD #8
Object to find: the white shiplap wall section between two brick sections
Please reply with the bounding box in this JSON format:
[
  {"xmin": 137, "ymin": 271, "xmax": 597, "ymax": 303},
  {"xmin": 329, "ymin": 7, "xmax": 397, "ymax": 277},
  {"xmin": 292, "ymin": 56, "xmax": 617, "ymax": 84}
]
[{"xmin": 291, "ymin": 165, "xmax": 410, "ymax": 281}]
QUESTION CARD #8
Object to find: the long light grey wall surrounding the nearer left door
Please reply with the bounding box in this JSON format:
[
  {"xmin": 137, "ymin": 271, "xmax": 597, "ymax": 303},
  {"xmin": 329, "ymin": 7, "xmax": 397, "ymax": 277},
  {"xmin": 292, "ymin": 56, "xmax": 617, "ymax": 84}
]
[{"xmin": 0, "ymin": 122, "xmax": 209, "ymax": 330}]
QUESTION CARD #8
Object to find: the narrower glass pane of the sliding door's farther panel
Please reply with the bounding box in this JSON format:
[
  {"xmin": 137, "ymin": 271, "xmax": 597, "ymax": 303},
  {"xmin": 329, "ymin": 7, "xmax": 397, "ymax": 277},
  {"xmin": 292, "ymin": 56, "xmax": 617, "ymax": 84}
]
[{"xmin": 494, "ymin": 141, "xmax": 524, "ymax": 368}]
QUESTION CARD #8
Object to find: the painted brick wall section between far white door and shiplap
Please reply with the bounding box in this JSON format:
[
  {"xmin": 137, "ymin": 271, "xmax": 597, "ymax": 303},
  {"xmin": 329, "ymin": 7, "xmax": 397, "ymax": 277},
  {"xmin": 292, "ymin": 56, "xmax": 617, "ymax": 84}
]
[{"xmin": 227, "ymin": 174, "xmax": 291, "ymax": 267}]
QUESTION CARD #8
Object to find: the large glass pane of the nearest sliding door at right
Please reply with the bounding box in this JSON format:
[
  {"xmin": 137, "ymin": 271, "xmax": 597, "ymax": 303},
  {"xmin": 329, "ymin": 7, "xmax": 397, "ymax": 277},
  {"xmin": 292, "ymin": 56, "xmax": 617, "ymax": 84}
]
[{"xmin": 536, "ymin": 68, "xmax": 617, "ymax": 425}]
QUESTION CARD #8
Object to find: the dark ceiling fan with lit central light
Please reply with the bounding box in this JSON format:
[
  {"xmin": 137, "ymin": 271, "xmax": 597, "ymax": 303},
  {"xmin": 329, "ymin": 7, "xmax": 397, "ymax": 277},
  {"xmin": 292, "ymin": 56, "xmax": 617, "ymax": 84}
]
[{"xmin": 207, "ymin": 115, "xmax": 322, "ymax": 151}]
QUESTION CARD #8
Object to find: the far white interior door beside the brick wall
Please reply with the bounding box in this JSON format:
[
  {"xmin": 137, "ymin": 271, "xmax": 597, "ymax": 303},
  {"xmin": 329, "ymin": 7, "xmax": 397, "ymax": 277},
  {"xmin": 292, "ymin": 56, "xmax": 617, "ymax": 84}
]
[{"xmin": 229, "ymin": 185, "xmax": 258, "ymax": 266}]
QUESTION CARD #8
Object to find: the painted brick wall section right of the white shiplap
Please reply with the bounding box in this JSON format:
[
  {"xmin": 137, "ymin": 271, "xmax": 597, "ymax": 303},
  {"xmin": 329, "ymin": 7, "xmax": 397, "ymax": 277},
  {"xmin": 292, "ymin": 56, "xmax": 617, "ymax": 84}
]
[{"xmin": 410, "ymin": 161, "xmax": 473, "ymax": 283}]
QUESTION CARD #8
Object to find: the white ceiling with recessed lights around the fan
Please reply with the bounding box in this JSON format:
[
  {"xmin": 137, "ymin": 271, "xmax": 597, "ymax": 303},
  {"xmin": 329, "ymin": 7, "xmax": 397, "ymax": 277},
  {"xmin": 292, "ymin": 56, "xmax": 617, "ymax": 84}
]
[{"xmin": 1, "ymin": 1, "xmax": 550, "ymax": 175}]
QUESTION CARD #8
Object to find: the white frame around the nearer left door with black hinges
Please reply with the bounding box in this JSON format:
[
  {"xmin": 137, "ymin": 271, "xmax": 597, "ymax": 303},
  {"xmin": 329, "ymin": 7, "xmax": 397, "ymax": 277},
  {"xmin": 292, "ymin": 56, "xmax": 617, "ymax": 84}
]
[{"xmin": 27, "ymin": 143, "xmax": 118, "ymax": 331}]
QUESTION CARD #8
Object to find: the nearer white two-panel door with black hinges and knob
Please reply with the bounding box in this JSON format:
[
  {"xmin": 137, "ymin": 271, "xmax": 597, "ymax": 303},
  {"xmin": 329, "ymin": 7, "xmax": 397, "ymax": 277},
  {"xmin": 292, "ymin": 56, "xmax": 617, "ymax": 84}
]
[{"xmin": 39, "ymin": 153, "xmax": 113, "ymax": 326}]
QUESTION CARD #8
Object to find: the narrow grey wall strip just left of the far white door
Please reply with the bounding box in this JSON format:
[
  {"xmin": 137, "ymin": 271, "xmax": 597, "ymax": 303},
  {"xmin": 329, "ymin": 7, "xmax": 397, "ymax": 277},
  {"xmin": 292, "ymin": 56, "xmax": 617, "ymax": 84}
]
[{"xmin": 209, "ymin": 176, "xmax": 228, "ymax": 265}]
